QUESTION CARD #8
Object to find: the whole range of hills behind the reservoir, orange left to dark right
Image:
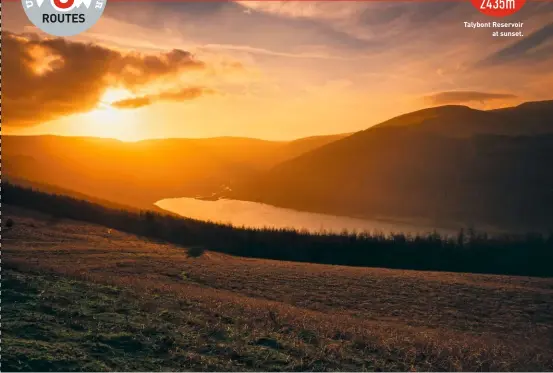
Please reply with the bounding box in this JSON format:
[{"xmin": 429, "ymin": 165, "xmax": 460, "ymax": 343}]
[{"xmin": 2, "ymin": 101, "xmax": 553, "ymax": 230}]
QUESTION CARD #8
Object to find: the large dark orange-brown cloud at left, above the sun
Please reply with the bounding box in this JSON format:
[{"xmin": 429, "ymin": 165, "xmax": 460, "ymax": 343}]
[{"xmin": 2, "ymin": 32, "xmax": 204, "ymax": 126}]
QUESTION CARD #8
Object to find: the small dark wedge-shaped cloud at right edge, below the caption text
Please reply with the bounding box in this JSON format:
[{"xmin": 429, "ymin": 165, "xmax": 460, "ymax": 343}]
[{"xmin": 478, "ymin": 23, "xmax": 553, "ymax": 66}]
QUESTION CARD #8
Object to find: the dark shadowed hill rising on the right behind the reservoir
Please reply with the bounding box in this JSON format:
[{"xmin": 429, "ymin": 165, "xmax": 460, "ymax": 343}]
[{"xmin": 229, "ymin": 101, "xmax": 553, "ymax": 229}]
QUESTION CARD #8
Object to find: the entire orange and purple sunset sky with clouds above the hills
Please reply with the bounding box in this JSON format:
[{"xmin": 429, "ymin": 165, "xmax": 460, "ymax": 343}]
[{"xmin": 2, "ymin": 1, "xmax": 553, "ymax": 140}]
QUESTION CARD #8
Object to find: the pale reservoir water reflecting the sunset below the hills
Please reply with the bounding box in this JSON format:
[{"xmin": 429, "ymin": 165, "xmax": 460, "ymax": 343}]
[{"xmin": 155, "ymin": 198, "xmax": 457, "ymax": 234}]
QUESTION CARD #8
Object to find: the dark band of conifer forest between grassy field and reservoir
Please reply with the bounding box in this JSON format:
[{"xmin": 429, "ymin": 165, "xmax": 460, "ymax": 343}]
[{"xmin": 2, "ymin": 183, "xmax": 553, "ymax": 276}]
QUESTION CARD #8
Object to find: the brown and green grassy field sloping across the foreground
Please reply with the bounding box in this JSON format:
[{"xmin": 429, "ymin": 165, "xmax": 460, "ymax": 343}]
[{"xmin": 2, "ymin": 205, "xmax": 553, "ymax": 371}]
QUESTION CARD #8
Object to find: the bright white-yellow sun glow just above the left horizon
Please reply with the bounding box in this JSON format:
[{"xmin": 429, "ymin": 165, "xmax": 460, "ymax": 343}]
[{"xmin": 83, "ymin": 89, "xmax": 142, "ymax": 141}]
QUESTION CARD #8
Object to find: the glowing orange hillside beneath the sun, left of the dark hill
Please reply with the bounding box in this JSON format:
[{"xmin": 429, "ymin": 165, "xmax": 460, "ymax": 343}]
[{"xmin": 2, "ymin": 135, "xmax": 345, "ymax": 207}]
